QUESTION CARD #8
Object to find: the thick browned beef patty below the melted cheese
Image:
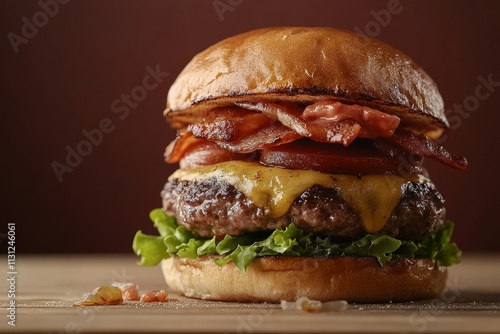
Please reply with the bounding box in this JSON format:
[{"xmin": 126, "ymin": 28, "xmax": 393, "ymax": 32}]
[{"xmin": 162, "ymin": 178, "xmax": 445, "ymax": 240}]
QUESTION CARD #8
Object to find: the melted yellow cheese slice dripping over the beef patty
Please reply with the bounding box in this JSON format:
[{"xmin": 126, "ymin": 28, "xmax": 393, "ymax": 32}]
[{"xmin": 169, "ymin": 161, "xmax": 427, "ymax": 233}]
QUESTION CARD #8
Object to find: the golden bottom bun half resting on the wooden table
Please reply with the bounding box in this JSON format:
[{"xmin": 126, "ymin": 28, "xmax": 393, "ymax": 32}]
[{"xmin": 162, "ymin": 256, "xmax": 447, "ymax": 303}]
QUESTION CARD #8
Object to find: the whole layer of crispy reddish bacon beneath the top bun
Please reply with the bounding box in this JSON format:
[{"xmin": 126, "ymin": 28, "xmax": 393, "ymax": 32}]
[{"xmin": 165, "ymin": 101, "xmax": 467, "ymax": 171}]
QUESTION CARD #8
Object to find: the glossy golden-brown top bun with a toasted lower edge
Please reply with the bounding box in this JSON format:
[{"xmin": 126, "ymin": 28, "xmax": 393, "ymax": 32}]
[{"xmin": 165, "ymin": 27, "xmax": 448, "ymax": 138}]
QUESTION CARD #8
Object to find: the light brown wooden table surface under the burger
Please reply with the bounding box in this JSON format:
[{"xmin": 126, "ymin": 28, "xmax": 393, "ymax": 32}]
[{"xmin": 0, "ymin": 254, "xmax": 500, "ymax": 333}]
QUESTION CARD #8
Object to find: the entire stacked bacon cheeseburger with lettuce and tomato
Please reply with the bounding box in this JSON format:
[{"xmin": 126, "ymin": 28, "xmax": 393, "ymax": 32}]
[{"xmin": 133, "ymin": 27, "xmax": 467, "ymax": 302}]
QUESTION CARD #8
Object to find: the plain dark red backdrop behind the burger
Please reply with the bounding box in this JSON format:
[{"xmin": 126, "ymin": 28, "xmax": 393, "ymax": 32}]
[{"xmin": 0, "ymin": 0, "xmax": 500, "ymax": 253}]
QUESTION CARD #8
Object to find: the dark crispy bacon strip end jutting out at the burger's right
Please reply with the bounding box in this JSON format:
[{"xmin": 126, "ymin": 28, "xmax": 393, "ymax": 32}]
[{"xmin": 375, "ymin": 129, "xmax": 468, "ymax": 171}]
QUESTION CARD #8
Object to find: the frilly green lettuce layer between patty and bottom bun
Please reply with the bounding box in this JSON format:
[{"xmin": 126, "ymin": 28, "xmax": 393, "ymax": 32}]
[{"xmin": 132, "ymin": 209, "xmax": 461, "ymax": 271}]
